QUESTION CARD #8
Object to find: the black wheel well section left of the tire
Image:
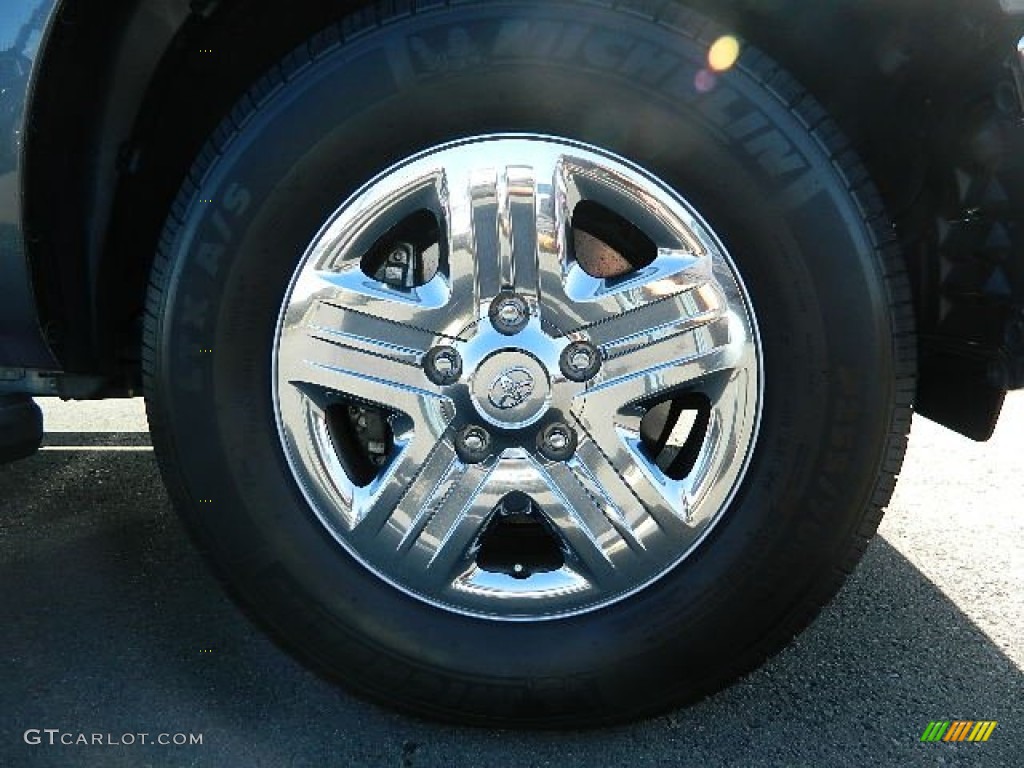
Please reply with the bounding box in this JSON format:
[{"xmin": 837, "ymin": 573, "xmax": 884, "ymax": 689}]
[{"xmin": 25, "ymin": 0, "xmax": 360, "ymax": 378}]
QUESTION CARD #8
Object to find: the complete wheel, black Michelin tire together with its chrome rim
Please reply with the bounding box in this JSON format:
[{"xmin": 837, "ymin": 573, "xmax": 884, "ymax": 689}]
[{"xmin": 143, "ymin": 0, "xmax": 914, "ymax": 727}]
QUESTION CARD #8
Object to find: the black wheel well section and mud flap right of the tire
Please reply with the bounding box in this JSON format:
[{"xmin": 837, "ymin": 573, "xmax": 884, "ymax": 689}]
[{"xmin": 697, "ymin": 0, "xmax": 1024, "ymax": 439}]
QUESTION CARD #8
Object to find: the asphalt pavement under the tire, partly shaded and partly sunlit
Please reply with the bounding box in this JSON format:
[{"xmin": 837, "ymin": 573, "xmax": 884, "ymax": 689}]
[{"xmin": 0, "ymin": 393, "xmax": 1024, "ymax": 768}]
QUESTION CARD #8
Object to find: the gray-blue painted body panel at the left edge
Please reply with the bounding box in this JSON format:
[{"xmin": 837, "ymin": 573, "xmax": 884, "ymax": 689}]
[{"xmin": 0, "ymin": 0, "xmax": 58, "ymax": 369}]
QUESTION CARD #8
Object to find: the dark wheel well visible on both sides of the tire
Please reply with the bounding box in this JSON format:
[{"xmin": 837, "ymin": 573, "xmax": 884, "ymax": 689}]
[{"xmin": 19, "ymin": 0, "xmax": 1024, "ymax": 433}]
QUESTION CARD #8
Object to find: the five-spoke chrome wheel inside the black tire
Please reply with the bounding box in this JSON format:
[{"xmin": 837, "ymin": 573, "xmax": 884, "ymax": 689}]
[{"xmin": 273, "ymin": 135, "xmax": 763, "ymax": 621}]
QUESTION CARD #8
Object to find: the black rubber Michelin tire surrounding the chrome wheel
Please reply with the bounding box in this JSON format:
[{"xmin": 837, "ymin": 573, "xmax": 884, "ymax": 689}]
[{"xmin": 143, "ymin": 0, "xmax": 914, "ymax": 727}]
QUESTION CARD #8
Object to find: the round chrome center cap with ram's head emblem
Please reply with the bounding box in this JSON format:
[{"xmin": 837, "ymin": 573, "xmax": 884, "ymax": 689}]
[{"xmin": 472, "ymin": 350, "xmax": 551, "ymax": 427}]
